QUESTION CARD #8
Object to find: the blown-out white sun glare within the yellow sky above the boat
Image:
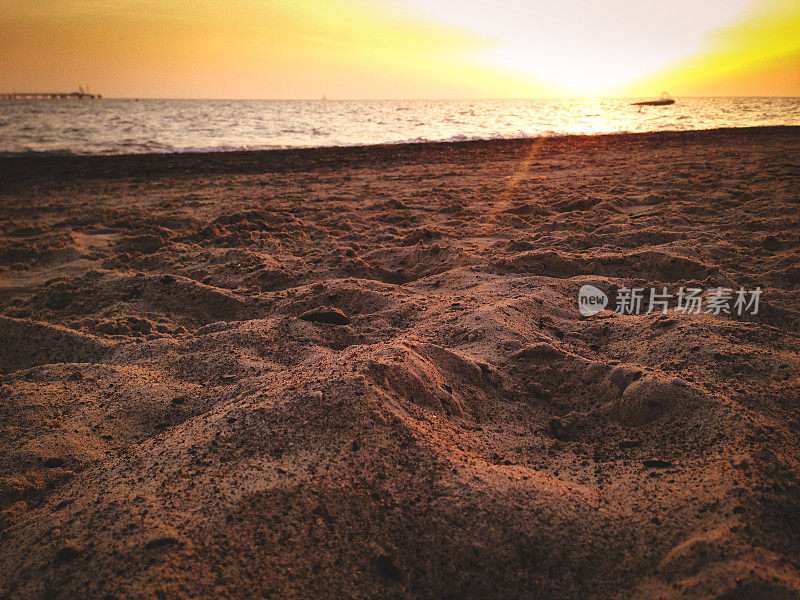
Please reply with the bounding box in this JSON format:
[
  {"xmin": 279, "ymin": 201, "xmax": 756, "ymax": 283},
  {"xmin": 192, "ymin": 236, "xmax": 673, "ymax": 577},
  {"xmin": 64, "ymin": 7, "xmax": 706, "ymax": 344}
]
[{"xmin": 406, "ymin": 0, "xmax": 748, "ymax": 94}]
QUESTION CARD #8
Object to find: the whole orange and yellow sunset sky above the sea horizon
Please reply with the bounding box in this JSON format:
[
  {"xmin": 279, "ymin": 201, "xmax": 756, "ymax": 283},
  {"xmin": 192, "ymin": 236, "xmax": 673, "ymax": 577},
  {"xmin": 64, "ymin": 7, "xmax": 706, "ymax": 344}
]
[{"xmin": 0, "ymin": 0, "xmax": 800, "ymax": 99}]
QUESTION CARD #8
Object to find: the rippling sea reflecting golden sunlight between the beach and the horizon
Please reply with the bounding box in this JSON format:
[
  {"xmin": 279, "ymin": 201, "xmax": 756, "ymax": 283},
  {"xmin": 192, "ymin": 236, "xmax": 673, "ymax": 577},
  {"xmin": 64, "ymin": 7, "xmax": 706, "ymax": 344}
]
[{"xmin": 0, "ymin": 97, "xmax": 800, "ymax": 155}]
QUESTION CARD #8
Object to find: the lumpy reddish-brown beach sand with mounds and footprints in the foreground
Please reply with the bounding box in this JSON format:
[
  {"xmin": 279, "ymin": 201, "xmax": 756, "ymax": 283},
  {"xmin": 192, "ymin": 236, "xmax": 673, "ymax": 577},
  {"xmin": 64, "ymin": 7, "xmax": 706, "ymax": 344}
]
[{"xmin": 0, "ymin": 128, "xmax": 800, "ymax": 600}]
